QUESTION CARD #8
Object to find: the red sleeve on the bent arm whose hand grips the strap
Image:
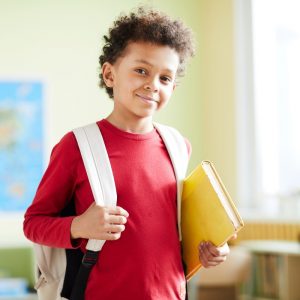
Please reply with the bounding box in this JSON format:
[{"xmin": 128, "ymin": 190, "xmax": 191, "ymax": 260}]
[{"xmin": 23, "ymin": 132, "xmax": 81, "ymax": 248}]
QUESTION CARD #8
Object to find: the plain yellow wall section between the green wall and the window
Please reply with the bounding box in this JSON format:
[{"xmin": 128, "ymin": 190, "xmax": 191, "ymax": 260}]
[{"xmin": 199, "ymin": 0, "xmax": 237, "ymax": 201}]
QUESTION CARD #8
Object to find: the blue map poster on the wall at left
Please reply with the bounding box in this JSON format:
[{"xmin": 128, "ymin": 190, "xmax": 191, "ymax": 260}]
[{"xmin": 0, "ymin": 81, "xmax": 43, "ymax": 213}]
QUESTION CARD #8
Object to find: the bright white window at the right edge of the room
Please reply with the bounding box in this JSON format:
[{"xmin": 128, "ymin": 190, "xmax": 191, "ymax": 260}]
[{"xmin": 236, "ymin": 0, "xmax": 300, "ymax": 218}]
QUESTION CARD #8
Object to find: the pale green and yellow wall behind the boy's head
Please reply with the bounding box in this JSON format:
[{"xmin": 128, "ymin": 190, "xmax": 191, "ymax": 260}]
[{"xmin": 0, "ymin": 0, "xmax": 236, "ymax": 238}]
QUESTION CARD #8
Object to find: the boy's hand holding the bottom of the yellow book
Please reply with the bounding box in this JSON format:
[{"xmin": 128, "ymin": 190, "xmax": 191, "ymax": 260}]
[{"xmin": 199, "ymin": 242, "xmax": 230, "ymax": 268}]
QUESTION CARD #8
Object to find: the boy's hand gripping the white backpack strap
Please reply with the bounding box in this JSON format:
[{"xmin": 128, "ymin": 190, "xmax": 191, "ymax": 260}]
[{"xmin": 71, "ymin": 203, "xmax": 129, "ymax": 240}]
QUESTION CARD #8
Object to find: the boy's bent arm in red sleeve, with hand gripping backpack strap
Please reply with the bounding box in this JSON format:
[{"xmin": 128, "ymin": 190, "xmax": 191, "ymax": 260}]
[{"xmin": 24, "ymin": 133, "xmax": 128, "ymax": 248}]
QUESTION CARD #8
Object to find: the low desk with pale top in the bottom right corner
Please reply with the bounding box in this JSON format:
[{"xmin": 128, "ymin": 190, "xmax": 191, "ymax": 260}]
[{"xmin": 240, "ymin": 240, "xmax": 300, "ymax": 300}]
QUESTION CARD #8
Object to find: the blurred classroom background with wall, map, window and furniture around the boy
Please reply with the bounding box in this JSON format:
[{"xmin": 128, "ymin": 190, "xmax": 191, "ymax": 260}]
[{"xmin": 0, "ymin": 0, "xmax": 300, "ymax": 300}]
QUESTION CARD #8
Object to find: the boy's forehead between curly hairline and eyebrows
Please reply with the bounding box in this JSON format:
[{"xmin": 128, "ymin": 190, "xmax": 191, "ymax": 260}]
[{"xmin": 121, "ymin": 42, "xmax": 179, "ymax": 73}]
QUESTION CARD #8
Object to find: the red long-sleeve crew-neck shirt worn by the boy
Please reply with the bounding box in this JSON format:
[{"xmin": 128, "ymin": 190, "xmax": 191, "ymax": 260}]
[{"xmin": 24, "ymin": 120, "xmax": 189, "ymax": 300}]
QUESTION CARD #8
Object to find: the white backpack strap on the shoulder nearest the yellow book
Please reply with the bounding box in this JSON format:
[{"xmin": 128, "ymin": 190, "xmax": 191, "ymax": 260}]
[{"xmin": 153, "ymin": 123, "xmax": 189, "ymax": 241}]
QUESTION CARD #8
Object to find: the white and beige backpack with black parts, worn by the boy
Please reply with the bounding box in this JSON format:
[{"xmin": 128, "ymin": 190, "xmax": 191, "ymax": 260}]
[{"xmin": 34, "ymin": 123, "xmax": 189, "ymax": 300}]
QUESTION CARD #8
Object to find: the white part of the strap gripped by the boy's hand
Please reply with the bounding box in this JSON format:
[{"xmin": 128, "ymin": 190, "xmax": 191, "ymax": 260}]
[{"xmin": 73, "ymin": 123, "xmax": 117, "ymax": 251}]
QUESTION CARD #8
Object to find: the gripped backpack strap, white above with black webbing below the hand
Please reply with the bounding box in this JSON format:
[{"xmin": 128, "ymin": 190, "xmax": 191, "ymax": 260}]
[{"xmin": 70, "ymin": 123, "xmax": 117, "ymax": 300}]
